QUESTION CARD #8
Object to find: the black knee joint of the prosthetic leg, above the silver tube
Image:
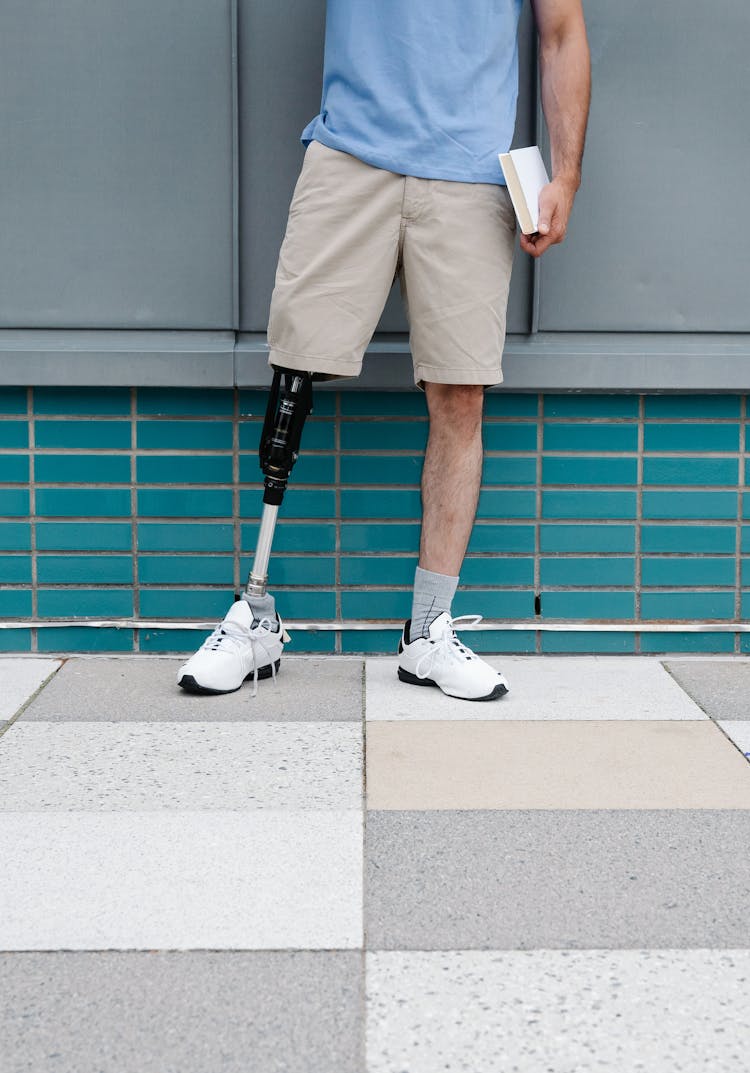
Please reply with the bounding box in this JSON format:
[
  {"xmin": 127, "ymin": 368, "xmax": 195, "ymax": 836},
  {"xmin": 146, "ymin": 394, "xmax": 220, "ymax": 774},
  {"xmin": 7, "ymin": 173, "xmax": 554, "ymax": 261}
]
[{"xmin": 259, "ymin": 367, "xmax": 312, "ymax": 505}]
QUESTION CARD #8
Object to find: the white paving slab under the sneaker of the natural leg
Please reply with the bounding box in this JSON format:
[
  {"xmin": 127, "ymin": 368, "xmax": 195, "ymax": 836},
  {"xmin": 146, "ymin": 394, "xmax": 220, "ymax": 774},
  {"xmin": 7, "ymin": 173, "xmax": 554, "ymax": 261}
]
[{"xmin": 366, "ymin": 652, "xmax": 707, "ymax": 721}]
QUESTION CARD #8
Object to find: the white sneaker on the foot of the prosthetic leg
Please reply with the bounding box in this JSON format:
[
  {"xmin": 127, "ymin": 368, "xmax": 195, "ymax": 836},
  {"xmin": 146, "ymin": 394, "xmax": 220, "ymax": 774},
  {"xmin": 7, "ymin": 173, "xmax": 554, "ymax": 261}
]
[{"xmin": 177, "ymin": 600, "xmax": 289, "ymax": 696}]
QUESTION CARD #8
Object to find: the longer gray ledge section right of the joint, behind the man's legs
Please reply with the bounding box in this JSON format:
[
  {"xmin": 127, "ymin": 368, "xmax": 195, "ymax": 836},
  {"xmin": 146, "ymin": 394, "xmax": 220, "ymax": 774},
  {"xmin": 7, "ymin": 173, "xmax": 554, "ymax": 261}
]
[{"xmin": 235, "ymin": 332, "xmax": 750, "ymax": 393}]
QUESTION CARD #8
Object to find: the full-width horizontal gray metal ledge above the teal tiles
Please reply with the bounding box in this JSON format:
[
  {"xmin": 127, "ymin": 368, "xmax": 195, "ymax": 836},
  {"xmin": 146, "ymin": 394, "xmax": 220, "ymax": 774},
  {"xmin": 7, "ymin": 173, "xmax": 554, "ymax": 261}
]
[{"xmin": 0, "ymin": 328, "xmax": 750, "ymax": 394}]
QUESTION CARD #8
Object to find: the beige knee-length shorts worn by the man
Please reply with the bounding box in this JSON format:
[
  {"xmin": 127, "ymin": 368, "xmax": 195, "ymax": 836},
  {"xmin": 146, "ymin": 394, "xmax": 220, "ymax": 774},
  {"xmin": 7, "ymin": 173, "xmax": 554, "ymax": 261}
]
[{"xmin": 268, "ymin": 141, "xmax": 516, "ymax": 387}]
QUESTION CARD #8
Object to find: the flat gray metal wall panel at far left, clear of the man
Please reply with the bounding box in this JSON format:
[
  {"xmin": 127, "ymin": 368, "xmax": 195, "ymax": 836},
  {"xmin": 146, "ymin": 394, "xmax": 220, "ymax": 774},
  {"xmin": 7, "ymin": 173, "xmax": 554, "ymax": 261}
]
[{"xmin": 0, "ymin": 0, "xmax": 235, "ymax": 328}]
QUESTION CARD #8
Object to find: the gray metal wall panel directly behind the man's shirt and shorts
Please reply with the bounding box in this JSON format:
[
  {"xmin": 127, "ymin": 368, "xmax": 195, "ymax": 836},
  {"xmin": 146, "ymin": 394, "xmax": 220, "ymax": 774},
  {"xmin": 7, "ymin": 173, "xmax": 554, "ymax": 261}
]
[{"xmin": 238, "ymin": 0, "xmax": 535, "ymax": 332}]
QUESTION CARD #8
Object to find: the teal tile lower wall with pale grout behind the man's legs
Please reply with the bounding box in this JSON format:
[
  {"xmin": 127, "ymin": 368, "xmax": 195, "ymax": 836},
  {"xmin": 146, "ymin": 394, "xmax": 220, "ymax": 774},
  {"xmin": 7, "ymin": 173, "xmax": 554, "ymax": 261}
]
[{"xmin": 0, "ymin": 387, "xmax": 750, "ymax": 653}]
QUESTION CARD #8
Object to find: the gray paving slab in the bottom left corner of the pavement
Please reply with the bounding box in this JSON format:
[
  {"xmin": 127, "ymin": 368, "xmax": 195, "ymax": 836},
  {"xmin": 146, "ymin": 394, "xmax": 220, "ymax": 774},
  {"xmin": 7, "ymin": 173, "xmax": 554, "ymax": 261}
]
[{"xmin": 0, "ymin": 951, "xmax": 365, "ymax": 1073}]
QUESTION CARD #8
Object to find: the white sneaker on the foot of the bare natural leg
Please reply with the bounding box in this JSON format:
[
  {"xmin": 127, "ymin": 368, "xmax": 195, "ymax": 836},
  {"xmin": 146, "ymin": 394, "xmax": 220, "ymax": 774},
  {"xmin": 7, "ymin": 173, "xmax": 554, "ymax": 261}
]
[{"xmin": 398, "ymin": 611, "xmax": 509, "ymax": 701}]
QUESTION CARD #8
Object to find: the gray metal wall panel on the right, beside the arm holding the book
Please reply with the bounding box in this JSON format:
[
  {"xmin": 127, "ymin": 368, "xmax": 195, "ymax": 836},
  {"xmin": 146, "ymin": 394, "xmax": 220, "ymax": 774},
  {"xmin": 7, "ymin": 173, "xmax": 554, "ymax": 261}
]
[{"xmin": 541, "ymin": 0, "xmax": 750, "ymax": 332}]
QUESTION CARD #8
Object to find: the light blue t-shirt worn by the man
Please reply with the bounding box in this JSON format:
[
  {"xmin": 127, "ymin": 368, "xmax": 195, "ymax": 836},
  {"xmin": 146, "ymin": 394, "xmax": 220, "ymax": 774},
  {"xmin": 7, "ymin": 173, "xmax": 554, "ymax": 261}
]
[{"xmin": 300, "ymin": 0, "xmax": 523, "ymax": 186}]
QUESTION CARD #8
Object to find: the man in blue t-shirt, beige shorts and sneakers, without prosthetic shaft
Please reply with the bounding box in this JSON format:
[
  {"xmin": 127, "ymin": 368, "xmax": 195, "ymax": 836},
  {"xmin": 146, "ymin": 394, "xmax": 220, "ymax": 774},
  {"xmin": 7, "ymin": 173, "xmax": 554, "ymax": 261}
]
[{"xmin": 178, "ymin": 0, "xmax": 590, "ymax": 701}]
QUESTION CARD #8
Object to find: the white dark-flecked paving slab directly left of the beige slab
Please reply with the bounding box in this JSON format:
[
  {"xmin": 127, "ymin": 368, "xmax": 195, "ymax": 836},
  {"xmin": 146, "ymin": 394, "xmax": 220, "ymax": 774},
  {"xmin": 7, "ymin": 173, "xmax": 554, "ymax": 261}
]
[{"xmin": 0, "ymin": 720, "xmax": 363, "ymax": 812}]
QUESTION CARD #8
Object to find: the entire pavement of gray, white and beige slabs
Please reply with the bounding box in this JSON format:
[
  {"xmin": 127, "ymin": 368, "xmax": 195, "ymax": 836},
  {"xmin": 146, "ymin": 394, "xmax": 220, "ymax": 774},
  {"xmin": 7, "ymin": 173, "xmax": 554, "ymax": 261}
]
[{"xmin": 0, "ymin": 657, "xmax": 750, "ymax": 1073}]
